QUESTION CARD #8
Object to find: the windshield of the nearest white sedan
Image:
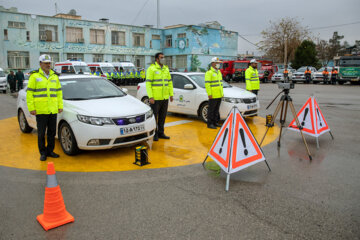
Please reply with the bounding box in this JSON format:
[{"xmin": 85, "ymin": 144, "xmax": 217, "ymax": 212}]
[{"xmin": 60, "ymin": 78, "xmax": 126, "ymax": 100}]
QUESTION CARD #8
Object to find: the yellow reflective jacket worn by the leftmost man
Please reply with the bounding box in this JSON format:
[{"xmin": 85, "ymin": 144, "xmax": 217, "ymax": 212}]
[{"xmin": 26, "ymin": 68, "xmax": 63, "ymax": 114}]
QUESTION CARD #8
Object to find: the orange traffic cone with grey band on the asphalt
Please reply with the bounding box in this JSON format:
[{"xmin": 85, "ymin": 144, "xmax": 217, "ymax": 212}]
[{"xmin": 36, "ymin": 162, "xmax": 74, "ymax": 231}]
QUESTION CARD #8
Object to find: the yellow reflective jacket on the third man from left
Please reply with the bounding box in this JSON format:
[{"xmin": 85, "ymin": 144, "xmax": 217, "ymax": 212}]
[{"xmin": 205, "ymin": 67, "xmax": 224, "ymax": 98}]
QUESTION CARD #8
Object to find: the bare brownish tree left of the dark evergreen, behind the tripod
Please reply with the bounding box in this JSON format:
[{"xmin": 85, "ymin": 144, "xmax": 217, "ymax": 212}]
[{"xmin": 259, "ymin": 17, "xmax": 310, "ymax": 64}]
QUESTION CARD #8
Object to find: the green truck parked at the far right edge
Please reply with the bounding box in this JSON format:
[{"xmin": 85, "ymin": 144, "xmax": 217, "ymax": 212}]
[{"xmin": 338, "ymin": 56, "xmax": 360, "ymax": 84}]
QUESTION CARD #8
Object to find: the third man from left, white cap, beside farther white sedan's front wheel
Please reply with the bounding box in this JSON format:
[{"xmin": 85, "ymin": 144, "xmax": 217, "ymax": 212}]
[{"xmin": 205, "ymin": 57, "xmax": 224, "ymax": 129}]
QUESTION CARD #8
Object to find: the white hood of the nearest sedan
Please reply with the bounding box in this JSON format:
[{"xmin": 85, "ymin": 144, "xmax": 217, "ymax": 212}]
[{"xmin": 64, "ymin": 95, "xmax": 151, "ymax": 117}]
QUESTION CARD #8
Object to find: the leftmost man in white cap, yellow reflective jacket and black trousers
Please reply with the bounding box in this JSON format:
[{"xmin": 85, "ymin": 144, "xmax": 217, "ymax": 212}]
[{"xmin": 26, "ymin": 54, "xmax": 63, "ymax": 161}]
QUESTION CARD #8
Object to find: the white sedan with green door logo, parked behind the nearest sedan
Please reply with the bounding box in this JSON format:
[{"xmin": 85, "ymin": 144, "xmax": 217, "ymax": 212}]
[{"xmin": 136, "ymin": 72, "xmax": 260, "ymax": 122}]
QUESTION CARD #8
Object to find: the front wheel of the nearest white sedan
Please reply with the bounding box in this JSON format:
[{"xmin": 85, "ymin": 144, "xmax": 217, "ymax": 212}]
[{"xmin": 59, "ymin": 122, "xmax": 79, "ymax": 155}]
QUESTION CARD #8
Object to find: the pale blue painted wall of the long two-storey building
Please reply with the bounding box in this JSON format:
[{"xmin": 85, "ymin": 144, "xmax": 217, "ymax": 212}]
[{"xmin": 0, "ymin": 12, "xmax": 238, "ymax": 71}]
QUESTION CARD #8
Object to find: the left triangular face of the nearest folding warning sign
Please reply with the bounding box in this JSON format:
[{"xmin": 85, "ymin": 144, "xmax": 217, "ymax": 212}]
[{"xmin": 208, "ymin": 112, "xmax": 234, "ymax": 172}]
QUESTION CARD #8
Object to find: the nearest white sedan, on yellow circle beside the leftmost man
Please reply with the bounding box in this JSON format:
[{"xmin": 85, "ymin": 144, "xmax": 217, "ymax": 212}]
[{"xmin": 17, "ymin": 75, "xmax": 156, "ymax": 155}]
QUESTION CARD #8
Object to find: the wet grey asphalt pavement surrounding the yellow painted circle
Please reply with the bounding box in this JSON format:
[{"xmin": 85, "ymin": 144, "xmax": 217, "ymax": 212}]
[{"xmin": 0, "ymin": 83, "xmax": 360, "ymax": 239}]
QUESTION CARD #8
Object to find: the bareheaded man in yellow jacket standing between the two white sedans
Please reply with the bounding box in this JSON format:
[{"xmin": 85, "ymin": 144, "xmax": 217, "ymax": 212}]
[{"xmin": 146, "ymin": 53, "xmax": 174, "ymax": 141}]
